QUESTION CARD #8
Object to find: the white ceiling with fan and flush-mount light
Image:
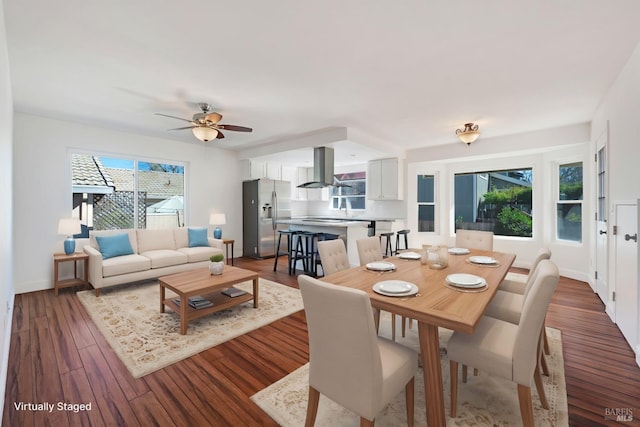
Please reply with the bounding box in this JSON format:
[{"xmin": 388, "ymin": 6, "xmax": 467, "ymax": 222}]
[{"xmin": 1, "ymin": 0, "xmax": 640, "ymax": 163}]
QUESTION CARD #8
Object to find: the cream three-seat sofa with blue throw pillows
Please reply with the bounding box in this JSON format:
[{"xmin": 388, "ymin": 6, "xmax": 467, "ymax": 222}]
[{"xmin": 83, "ymin": 227, "xmax": 223, "ymax": 296}]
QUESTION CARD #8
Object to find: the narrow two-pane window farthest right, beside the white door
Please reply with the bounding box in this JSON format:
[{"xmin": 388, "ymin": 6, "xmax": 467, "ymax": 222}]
[{"xmin": 556, "ymin": 162, "xmax": 582, "ymax": 242}]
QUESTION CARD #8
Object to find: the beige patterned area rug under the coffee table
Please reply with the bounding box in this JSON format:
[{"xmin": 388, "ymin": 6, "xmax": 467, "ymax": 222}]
[{"xmin": 77, "ymin": 279, "xmax": 303, "ymax": 378}]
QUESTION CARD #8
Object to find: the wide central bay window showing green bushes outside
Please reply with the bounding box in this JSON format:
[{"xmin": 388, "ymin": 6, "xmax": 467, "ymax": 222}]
[{"xmin": 454, "ymin": 168, "xmax": 533, "ymax": 237}]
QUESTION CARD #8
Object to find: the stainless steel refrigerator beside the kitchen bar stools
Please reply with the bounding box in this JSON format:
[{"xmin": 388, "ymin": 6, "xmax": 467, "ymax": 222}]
[{"xmin": 242, "ymin": 179, "xmax": 291, "ymax": 258}]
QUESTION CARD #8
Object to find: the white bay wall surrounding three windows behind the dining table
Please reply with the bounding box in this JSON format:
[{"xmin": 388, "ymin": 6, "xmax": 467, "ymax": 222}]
[{"xmin": 406, "ymin": 124, "xmax": 593, "ymax": 281}]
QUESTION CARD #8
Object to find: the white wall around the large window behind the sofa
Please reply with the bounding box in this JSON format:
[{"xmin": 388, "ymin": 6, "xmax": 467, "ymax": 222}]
[{"xmin": 12, "ymin": 113, "xmax": 242, "ymax": 293}]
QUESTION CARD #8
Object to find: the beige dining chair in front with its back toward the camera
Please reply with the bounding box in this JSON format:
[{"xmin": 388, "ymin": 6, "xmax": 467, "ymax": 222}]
[{"xmin": 298, "ymin": 275, "xmax": 418, "ymax": 427}]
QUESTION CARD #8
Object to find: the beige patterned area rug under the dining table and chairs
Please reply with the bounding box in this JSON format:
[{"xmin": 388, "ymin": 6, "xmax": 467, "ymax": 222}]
[{"xmin": 251, "ymin": 313, "xmax": 568, "ymax": 427}]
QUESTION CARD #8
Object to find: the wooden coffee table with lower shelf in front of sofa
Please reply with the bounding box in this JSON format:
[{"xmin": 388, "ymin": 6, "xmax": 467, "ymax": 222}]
[{"xmin": 158, "ymin": 265, "xmax": 258, "ymax": 335}]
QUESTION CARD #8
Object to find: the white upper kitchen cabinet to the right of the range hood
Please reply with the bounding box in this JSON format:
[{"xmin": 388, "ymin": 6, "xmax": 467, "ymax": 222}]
[{"xmin": 367, "ymin": 158, "xmax": 403, "ymax": 200}]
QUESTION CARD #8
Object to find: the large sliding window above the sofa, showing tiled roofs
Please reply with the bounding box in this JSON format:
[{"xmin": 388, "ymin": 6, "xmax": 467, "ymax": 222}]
[{"xmin": 71, "ymin": 154, "xmax": 185, "ymax": 232}]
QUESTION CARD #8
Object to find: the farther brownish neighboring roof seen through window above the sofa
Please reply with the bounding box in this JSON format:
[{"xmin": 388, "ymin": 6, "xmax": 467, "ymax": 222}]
[{"xmin": 106, "ymin": 168, "xmax": 184, "ymax": 199}]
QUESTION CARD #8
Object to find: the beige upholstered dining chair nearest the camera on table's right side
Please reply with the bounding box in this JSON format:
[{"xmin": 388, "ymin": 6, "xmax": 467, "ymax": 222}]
[{"xmin": 447, "ymin": 260, "xmax": 559, "ymax": 427}]
